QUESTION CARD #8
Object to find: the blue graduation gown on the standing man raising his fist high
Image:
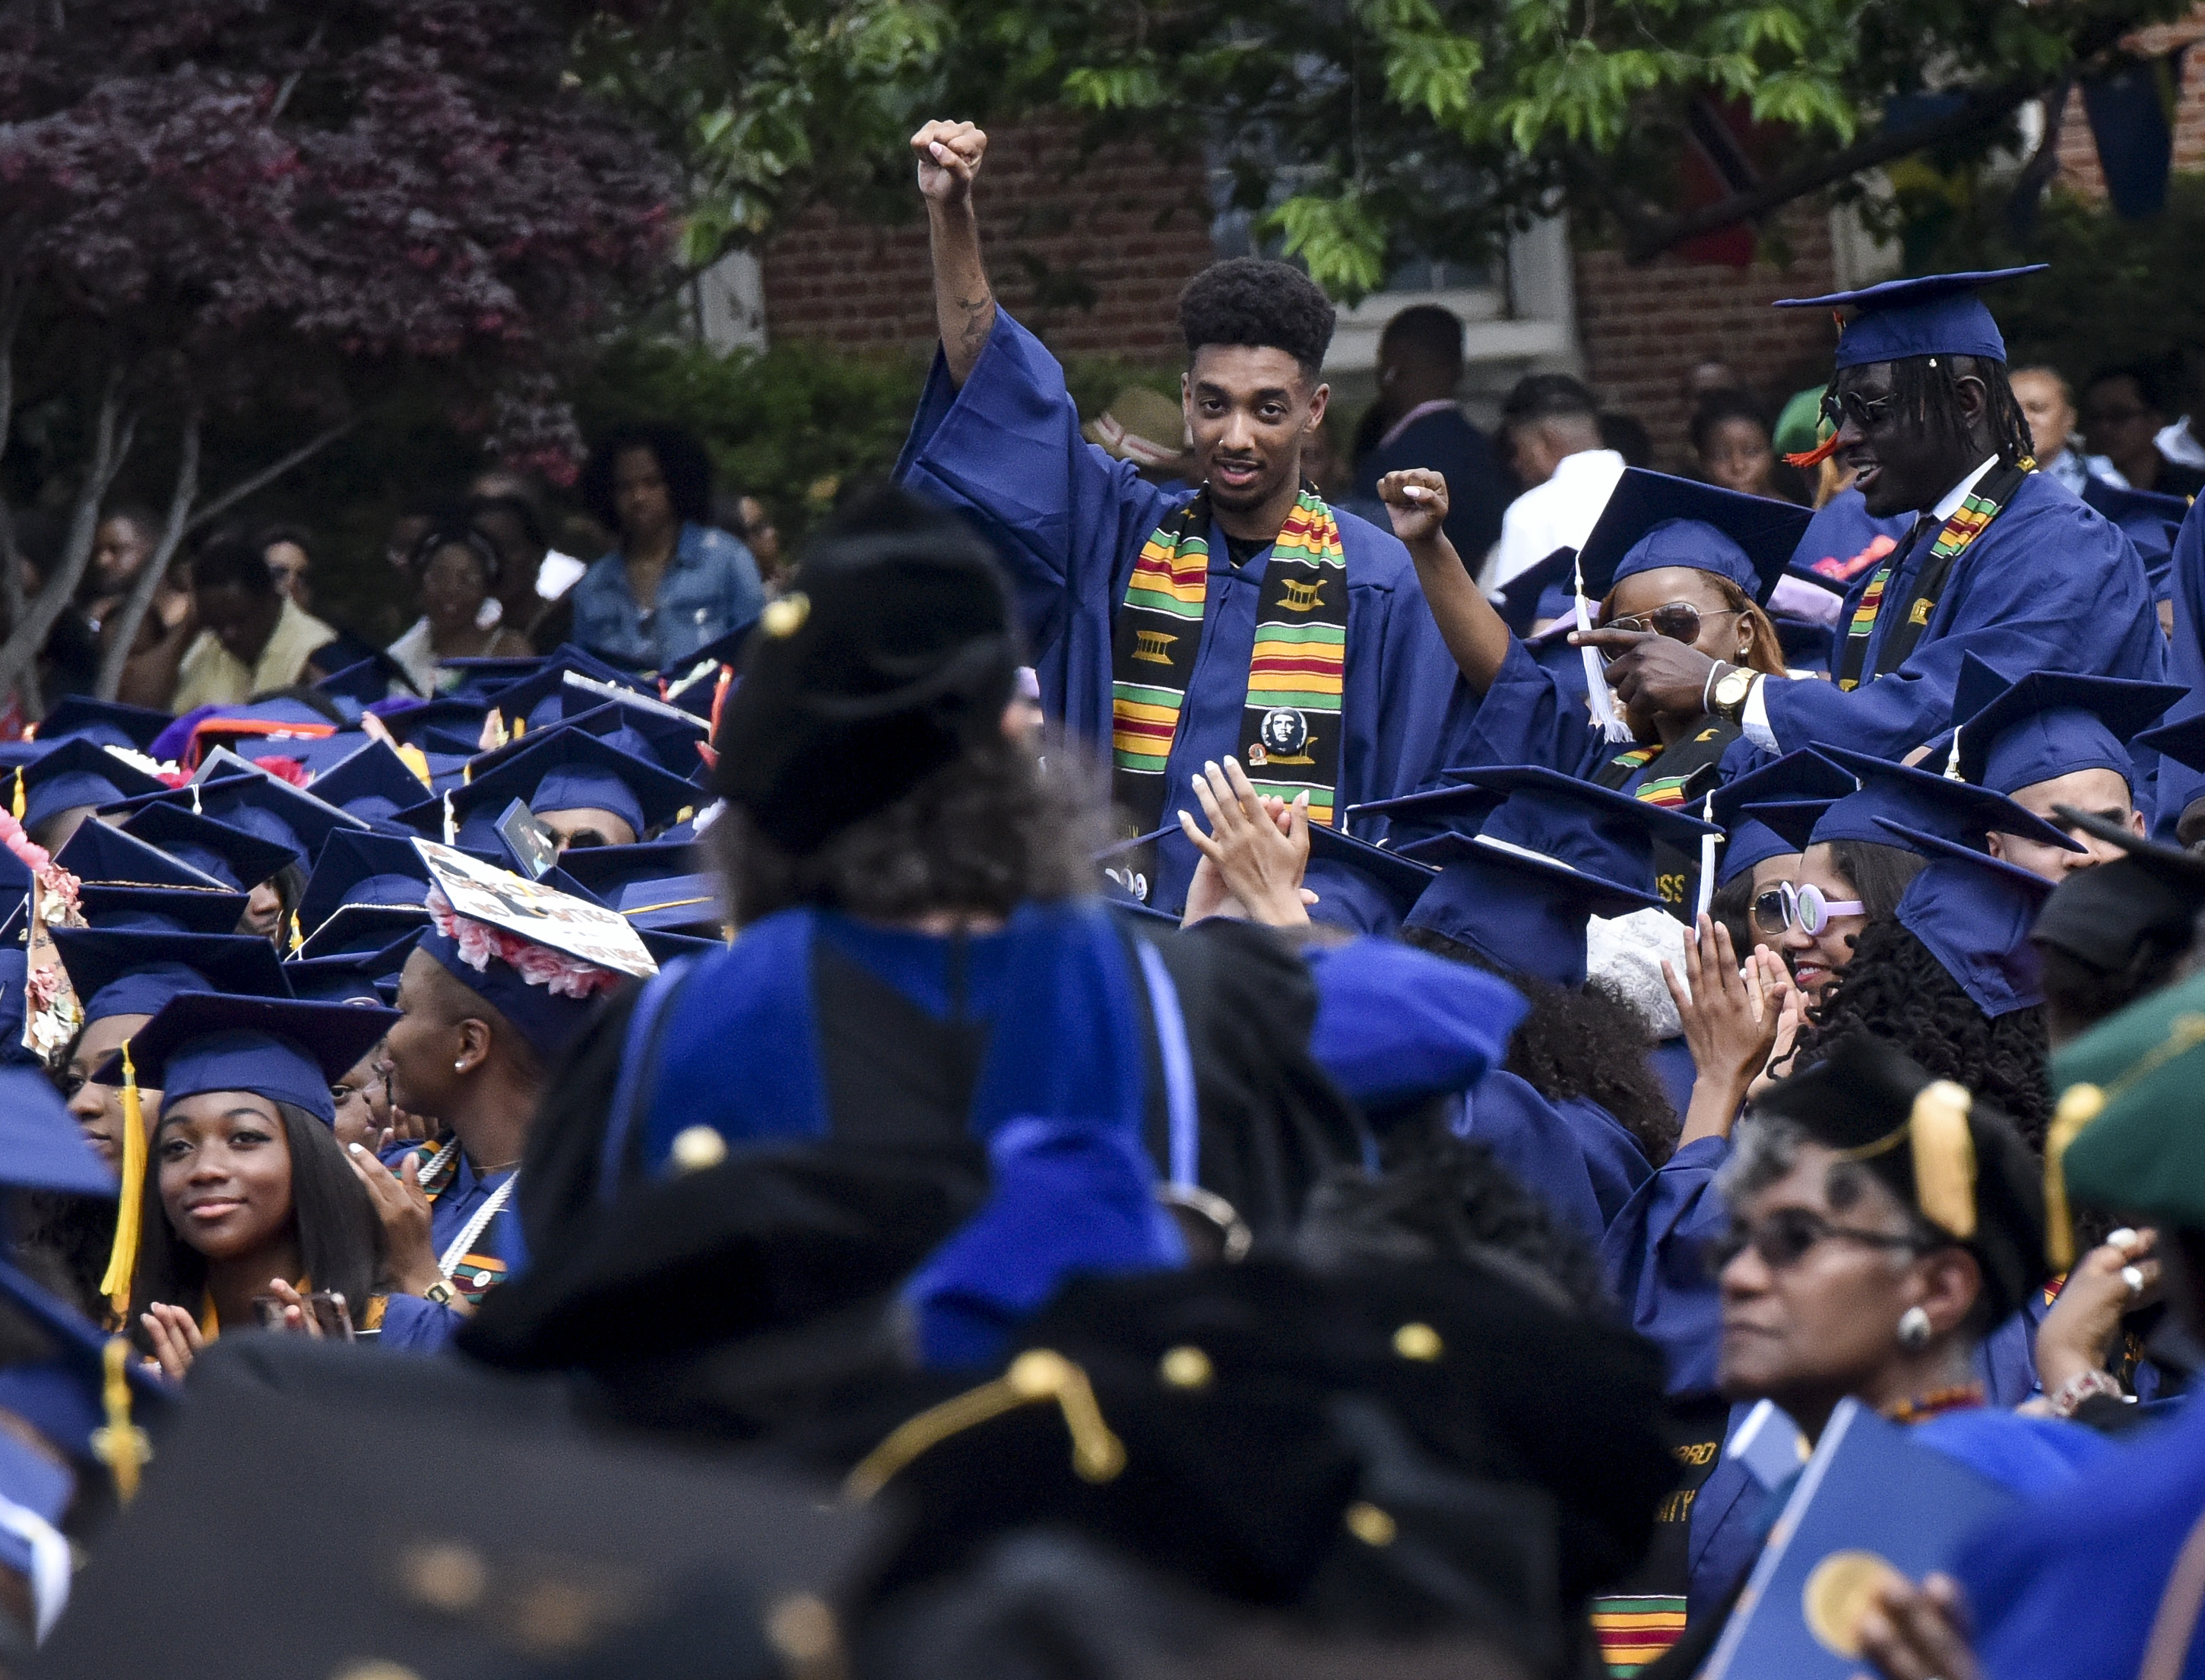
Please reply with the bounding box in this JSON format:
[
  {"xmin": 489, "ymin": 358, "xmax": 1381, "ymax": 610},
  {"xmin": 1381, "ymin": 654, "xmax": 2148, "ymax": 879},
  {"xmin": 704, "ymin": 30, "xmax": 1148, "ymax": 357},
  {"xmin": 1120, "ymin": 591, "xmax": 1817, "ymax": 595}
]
[{"xmin": 895, "ymin": 309, "xmax": 1456, "ymax": 913}]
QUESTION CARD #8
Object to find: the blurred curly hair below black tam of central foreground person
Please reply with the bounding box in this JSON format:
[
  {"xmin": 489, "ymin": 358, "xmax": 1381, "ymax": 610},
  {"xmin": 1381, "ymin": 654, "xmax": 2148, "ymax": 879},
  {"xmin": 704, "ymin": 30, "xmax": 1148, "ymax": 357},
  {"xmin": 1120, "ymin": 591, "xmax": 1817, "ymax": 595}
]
[{"xmin": 705, "ymin": 737, "xmax": 1109, "ymax": 926}]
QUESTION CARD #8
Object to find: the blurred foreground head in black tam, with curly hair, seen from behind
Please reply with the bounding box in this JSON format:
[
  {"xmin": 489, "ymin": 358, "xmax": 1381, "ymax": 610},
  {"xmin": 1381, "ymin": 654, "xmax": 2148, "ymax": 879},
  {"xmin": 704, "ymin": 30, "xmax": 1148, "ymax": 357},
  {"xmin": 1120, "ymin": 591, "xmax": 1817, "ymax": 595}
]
[{"xmin": 712, "ymin": 490, "xmax": 1091, "ymax": 924}]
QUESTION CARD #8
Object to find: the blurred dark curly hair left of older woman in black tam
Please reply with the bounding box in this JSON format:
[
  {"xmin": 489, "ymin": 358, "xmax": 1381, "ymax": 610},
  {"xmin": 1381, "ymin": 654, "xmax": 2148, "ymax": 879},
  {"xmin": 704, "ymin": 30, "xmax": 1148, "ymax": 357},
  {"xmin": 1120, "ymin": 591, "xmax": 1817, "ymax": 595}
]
[{"xmin": 1294, "ymin": 1129, "xmax": 1614, "ymax": 1316}]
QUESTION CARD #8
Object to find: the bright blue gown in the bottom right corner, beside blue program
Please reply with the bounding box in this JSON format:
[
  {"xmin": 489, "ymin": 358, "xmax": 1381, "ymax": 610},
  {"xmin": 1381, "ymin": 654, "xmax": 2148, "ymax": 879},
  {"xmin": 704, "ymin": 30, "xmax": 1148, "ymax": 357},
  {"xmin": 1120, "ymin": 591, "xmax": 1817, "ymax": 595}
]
[{"xmin": 1956, "ymin": 1404, "xmax": 2205, "ymax": 1680}]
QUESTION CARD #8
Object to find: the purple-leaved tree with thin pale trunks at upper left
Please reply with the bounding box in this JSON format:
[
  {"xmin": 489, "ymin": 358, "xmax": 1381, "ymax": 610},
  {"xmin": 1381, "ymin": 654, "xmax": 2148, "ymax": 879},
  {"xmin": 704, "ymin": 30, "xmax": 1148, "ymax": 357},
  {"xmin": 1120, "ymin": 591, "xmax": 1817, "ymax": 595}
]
[{"xmin": 0, "ymin": 0, "xmax": 675, "ymax": 695}]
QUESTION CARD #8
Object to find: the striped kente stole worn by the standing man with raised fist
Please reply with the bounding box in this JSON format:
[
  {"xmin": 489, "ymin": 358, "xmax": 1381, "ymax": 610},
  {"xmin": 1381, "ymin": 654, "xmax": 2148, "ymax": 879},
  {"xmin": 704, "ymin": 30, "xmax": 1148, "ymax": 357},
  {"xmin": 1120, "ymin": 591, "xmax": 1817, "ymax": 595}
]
[{"xmin": 1111, "ymin": 487, "xmax": 1348, "ymax": 833}]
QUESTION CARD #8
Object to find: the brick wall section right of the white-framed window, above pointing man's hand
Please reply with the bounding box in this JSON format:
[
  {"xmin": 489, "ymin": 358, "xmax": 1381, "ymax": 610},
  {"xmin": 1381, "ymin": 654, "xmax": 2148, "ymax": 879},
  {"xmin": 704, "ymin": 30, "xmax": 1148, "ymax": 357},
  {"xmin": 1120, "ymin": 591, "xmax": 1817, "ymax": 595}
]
[{"xmin": 1576, "ymin": 205, "xmax": 1835, "ymax": 468}]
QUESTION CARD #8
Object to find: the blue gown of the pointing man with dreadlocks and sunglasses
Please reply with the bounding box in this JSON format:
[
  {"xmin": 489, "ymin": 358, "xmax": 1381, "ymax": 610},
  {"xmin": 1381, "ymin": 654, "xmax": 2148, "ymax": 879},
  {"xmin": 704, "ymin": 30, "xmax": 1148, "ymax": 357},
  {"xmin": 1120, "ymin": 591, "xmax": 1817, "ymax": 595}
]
[{"xmin": 1762, "ymin": 472, "xmax": 2168, "ymax": 759}]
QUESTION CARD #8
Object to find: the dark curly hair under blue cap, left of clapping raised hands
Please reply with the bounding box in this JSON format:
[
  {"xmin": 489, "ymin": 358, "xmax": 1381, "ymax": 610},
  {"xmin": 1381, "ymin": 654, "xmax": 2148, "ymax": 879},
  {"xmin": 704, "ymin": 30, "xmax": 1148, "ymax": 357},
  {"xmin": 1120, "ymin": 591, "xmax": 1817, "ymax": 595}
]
[{"xmin": 1400, "ymin": 928, "xmax": 1678, "ymax": 1166}]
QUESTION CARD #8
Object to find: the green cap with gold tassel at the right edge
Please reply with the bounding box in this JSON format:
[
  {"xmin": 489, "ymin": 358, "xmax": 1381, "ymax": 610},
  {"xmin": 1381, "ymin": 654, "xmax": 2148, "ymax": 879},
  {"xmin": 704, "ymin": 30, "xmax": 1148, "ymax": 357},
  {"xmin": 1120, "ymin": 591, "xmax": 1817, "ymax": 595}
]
[{"xmin": 2044, "ymin": 961, "xmax": 2205, "ymax": 1266}]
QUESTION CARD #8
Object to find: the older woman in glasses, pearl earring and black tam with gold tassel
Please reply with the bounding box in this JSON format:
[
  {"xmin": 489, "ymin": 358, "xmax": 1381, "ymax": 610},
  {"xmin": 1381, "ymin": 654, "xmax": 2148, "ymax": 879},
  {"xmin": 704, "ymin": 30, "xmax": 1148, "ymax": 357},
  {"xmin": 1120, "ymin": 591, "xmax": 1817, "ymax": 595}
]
[{"xmin": 1649, "ymin": 1036, "xmax": 2108, "ymax": 1673}]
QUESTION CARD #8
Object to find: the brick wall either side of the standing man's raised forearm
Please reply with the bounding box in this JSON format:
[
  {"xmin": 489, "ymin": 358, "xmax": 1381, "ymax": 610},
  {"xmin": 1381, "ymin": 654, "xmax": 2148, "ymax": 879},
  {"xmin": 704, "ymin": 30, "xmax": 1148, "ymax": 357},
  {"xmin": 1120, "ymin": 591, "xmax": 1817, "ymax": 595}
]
[{"xmin": 763, "ymin": 123, "xmax": 1211, "ymax": 362}]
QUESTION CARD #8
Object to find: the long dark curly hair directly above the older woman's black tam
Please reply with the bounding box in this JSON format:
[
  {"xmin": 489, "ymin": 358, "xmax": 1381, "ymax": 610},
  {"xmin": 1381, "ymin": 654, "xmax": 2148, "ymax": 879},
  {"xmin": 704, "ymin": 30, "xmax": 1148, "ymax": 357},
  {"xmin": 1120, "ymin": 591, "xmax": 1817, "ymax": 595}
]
[{"xmin": 1793, "ymin": 919, "xmax": 2053, "ymax": 1153}]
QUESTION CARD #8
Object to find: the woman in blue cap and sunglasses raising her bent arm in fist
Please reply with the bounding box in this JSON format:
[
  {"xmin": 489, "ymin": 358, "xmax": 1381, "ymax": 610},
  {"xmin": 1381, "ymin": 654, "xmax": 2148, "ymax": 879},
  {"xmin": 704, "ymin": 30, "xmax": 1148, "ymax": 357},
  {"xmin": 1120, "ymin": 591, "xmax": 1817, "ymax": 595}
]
[{"xmin": 1378, "ymin": 468, "xmax": 1808, "ymax": 908}]
